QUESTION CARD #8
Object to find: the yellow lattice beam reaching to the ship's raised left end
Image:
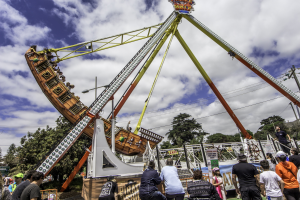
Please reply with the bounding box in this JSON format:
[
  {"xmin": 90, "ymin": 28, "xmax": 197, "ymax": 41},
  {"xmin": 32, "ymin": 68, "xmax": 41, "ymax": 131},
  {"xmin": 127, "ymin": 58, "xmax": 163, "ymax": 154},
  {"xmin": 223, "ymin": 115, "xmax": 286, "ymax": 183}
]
[{"xmin": 37, "ymin": 24, "xmax": 162, "ymax": 63}]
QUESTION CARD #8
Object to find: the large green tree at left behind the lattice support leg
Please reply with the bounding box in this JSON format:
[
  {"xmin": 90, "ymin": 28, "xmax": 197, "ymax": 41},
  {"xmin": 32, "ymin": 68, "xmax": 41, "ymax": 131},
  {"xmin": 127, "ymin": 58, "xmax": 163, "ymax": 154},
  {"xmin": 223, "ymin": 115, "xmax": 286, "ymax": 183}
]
[{"xmin": 14, "ymin": 116, "xmax": 90, "ymax": 183}]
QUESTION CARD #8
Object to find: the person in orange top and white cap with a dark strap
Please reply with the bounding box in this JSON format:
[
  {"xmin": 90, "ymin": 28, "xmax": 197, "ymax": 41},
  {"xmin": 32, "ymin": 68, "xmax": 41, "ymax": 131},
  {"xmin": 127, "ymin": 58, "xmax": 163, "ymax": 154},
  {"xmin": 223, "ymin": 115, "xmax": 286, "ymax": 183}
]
[{"xmin": 275, "ymin": 151, "xmax": 300, "ymax": 200}]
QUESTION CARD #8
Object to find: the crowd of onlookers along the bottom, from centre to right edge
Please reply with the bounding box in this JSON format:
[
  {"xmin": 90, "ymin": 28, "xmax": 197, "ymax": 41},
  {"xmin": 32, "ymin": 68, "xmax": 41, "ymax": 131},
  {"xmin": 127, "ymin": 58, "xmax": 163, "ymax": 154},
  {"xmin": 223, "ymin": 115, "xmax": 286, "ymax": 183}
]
[{"xmin": 99, "ymin": 144, "xmax": 300, "ymax": 200}]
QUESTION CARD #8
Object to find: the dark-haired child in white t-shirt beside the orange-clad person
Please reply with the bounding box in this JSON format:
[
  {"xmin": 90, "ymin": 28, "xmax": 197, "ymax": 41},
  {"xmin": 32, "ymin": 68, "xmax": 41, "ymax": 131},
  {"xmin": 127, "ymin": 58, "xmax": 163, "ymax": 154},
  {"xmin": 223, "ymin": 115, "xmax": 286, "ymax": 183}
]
[{"xmin": 259, "ymin": 160, "xmax": 284, "ymax": 200}]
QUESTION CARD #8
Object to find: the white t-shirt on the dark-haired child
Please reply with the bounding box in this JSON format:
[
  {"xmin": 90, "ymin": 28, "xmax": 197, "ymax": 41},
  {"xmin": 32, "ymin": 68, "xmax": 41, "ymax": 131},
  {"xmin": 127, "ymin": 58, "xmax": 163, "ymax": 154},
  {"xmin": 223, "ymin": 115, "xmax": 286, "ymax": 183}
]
[{"xmin": 259, "ymin": 171, "xmax": 282, "ymax": 197}]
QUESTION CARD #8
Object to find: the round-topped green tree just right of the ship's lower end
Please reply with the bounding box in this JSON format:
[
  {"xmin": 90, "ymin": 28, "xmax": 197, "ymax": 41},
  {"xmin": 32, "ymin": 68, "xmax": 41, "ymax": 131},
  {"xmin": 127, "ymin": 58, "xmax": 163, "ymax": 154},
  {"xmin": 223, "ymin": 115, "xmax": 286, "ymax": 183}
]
[{"xmin": 166, "ymin": 113, "xmax": 206, "ymax": 146}]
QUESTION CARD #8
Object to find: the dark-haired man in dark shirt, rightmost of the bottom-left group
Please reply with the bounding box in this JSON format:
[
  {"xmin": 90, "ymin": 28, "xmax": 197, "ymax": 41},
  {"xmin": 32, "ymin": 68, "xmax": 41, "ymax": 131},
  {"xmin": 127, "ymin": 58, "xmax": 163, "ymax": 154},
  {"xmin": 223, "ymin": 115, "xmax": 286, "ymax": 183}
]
[{"xmin": 20, "ymin": 172, "xmax": 44, "ymax": 200}]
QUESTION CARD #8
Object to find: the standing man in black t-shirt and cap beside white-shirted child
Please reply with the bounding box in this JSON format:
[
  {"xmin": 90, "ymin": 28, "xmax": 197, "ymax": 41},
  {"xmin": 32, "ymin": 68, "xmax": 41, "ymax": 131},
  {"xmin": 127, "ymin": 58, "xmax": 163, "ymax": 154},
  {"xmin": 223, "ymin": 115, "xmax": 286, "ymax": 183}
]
[{"xmin": 232, "ymin": 154, "xmax": 262, "ymax": 200}]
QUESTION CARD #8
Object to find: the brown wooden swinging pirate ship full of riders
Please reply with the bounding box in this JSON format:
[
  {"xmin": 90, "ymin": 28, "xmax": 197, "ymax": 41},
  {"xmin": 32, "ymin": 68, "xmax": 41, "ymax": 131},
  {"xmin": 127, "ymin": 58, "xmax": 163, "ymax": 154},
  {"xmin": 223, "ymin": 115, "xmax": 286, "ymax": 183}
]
[{"xmin": 25, "ymin": 46, "xmax": 163, "ymax": 156}]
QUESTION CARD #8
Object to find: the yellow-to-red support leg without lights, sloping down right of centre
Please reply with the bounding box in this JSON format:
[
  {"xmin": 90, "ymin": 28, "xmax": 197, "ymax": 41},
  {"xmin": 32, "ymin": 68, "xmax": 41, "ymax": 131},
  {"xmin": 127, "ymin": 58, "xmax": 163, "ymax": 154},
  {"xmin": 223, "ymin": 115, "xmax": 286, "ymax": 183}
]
[{"xmin": 175, "ymin": 30, "xmax": 252, "ymax": 139}]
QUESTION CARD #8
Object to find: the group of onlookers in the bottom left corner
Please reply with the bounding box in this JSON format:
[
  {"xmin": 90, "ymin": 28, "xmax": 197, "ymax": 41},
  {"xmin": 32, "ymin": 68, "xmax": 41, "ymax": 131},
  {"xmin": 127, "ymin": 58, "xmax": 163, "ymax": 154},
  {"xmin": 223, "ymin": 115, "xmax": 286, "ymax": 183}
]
[{"xmin": 0, "ymin": 170, "xmax": 44, "ymax": 200}]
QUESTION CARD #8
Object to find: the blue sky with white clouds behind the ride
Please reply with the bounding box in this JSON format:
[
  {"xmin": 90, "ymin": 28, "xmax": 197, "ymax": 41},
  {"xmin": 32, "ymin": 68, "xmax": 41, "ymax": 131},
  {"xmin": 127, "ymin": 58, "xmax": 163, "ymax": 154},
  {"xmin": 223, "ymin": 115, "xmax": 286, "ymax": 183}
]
[{"xmin": 0, "ymin": 0, "xmax": 300, "ymax": 153}]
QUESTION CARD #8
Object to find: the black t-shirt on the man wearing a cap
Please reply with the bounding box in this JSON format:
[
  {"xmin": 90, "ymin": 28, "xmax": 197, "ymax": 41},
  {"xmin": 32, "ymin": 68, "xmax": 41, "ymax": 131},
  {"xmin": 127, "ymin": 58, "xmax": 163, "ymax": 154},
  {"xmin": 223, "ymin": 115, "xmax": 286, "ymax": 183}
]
[{"xmin": 232, "ymin": 163, "xmax": 258, "ymax": 189}]
